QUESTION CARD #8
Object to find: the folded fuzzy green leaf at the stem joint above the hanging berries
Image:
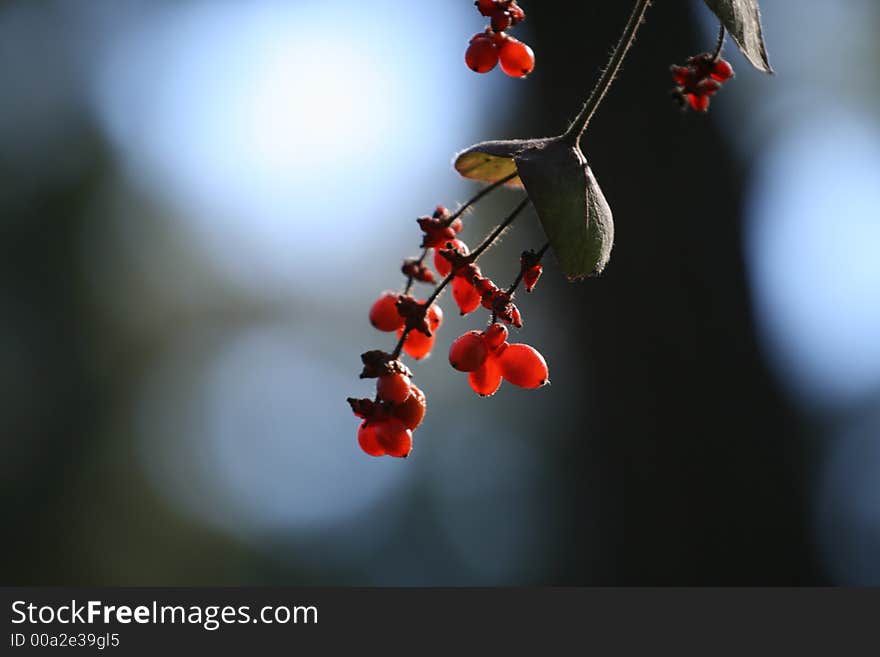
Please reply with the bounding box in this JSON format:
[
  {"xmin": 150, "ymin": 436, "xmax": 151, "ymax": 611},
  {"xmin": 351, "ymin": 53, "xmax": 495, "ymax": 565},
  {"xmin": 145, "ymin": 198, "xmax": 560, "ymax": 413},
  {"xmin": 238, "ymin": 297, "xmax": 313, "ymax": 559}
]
[{"xmin": 455, "ymin": 137, "xmax": 614, "ymax": 280}]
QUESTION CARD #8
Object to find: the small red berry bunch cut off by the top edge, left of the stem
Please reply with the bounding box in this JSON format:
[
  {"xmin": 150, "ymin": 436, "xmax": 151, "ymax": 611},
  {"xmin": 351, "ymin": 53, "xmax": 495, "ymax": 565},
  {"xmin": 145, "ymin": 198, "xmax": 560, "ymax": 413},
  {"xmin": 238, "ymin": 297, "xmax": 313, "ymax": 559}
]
[{"xmin": 464, "ymin": 0, "xmax": 535, "ymax": 78}]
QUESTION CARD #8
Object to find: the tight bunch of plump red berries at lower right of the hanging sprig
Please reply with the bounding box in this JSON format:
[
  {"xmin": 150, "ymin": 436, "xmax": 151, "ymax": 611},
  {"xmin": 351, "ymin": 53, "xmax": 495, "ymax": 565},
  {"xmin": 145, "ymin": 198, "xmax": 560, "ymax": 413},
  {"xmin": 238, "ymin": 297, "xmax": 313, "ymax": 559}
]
[{"xmin": 449, "ymin": 322, "xmax": 548, "ymax": 397}]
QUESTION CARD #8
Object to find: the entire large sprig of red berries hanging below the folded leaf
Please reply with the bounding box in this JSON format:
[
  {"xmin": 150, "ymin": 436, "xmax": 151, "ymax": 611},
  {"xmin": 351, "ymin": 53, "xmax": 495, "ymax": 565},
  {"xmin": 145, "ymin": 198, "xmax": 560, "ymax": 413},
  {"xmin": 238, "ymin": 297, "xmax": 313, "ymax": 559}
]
[{"xmin": 348, "ymin": 187, "xmax": 548, "ymax": 457}]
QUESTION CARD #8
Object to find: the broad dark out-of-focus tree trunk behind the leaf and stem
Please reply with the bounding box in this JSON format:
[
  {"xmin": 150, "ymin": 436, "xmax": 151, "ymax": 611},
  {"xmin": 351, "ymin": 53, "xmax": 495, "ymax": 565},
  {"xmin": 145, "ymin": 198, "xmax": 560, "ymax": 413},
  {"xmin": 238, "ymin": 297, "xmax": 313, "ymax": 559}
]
[{"xmin": 545, "ymin": 3, "xmax": 822, "ymax": 585}]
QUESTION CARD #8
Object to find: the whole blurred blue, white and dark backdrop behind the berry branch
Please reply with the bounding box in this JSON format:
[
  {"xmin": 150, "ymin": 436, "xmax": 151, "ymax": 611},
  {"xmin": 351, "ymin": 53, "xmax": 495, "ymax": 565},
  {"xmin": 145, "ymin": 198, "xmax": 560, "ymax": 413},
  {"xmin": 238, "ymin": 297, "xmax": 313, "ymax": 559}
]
[{"xmin": 0, "ymin": 0, "xmax": 880, "ymax": 585}]
